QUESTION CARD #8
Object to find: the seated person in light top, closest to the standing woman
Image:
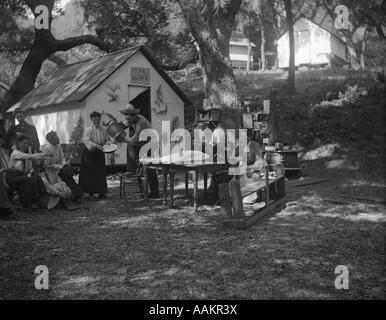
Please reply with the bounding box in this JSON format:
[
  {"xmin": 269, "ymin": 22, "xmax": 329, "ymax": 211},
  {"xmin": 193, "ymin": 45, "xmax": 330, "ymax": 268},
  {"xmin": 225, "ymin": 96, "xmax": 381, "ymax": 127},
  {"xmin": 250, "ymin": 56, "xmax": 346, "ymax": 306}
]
[{"xmin": 42, "ymin": 131, "xmax": 82, "ymax": 201}]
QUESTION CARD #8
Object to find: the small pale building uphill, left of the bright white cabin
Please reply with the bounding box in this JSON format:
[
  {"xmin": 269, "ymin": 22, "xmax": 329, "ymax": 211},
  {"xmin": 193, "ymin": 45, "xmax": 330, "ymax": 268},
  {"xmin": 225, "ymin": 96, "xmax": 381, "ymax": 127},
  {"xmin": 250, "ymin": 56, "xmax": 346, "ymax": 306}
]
[{"xmin": 229, "ymin": 37, "xmax": 256, "ymax": 69}]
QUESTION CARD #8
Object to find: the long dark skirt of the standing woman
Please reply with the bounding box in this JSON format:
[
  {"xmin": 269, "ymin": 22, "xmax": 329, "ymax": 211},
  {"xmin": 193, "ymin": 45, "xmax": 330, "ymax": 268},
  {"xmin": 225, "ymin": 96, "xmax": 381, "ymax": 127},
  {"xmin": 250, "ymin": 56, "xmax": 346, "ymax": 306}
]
[{"xmin": 79, "ymin": 148, "xmax": 107, "ymax": 194}]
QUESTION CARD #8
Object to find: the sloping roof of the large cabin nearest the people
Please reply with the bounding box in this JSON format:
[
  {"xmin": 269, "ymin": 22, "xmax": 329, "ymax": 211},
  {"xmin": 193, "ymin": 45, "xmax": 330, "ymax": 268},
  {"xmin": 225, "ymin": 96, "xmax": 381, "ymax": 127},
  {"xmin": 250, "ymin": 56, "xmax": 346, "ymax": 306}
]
[{"xmin": 8, "ymin": 46, "xmax": 192, "ymax": 112}]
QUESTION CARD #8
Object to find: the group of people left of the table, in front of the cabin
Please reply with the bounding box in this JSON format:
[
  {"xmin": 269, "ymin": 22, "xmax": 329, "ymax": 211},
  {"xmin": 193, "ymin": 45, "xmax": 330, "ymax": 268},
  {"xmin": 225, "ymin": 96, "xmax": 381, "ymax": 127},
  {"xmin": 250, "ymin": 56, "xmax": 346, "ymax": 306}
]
[{"xmin": 0, "ymin": 104, "xmax": 159, "ymax": 215}]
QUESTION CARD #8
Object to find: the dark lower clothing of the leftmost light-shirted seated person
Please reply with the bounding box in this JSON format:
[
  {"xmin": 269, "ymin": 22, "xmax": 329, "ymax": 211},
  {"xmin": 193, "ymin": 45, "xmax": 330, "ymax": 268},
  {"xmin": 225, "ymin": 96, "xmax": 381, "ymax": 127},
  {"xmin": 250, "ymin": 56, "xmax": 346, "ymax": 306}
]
[{"xmin": 6, "ymin": 170, "xmax": 46, "ymax": 205}]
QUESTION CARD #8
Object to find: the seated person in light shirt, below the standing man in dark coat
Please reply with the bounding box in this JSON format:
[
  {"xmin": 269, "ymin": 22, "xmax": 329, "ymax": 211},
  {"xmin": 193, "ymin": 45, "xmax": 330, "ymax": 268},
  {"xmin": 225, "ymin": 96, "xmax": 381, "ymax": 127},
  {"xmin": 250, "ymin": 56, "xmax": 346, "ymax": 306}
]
[{"xmin": 5, "ymin": 135, "xmax": 46, "ymax": 207}]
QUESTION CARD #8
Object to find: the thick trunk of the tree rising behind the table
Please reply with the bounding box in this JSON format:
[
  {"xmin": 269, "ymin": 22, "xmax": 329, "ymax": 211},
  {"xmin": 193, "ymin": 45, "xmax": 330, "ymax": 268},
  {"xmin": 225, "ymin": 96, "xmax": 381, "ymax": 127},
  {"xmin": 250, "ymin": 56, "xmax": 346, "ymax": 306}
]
[{"xmin": 178, "ymin": 0, "xmax": 242, "ymax": 129}]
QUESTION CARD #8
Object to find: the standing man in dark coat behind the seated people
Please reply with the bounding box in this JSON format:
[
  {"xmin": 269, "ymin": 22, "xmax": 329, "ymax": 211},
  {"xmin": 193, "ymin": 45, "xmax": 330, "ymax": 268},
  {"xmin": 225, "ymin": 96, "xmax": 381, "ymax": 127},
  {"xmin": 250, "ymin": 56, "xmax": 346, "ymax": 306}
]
[{"xmin": 3, "ymin": 109, "xmax": 40, "ymax": 153}]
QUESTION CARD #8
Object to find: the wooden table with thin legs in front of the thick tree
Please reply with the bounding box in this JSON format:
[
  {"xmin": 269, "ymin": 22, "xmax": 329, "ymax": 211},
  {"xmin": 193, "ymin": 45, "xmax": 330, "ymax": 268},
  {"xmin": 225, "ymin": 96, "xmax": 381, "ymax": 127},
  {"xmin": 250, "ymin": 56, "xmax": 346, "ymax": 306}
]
[{"xmin": 142, "ymin": 162, "xmax": 229, "ymax": 211}]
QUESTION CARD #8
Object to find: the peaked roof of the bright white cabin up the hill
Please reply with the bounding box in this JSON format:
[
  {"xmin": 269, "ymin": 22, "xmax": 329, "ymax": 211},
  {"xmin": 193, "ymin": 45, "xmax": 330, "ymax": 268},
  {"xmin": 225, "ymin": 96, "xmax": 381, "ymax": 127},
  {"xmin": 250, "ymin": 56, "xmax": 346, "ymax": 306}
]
[{"xmin": 277, "ymin": 7, "xmax": 346, "ymax": 43}]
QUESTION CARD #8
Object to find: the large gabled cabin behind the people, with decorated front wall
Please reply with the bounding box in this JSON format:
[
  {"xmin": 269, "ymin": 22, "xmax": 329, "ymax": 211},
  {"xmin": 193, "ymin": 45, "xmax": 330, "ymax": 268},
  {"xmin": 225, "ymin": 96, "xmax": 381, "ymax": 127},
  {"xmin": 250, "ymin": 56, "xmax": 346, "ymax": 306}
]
[{"xmin": 8, "ymin": 46, "xmax": 191, "ymax": 164}]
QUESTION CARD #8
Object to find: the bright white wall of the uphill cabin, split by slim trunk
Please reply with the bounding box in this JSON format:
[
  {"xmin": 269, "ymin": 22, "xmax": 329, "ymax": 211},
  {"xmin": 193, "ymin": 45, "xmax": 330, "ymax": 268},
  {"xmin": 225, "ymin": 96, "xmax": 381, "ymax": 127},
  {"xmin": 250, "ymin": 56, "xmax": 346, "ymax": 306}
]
[{"xmin": 278, "ymin": 18, "xmax": 333, "ymax": 68}]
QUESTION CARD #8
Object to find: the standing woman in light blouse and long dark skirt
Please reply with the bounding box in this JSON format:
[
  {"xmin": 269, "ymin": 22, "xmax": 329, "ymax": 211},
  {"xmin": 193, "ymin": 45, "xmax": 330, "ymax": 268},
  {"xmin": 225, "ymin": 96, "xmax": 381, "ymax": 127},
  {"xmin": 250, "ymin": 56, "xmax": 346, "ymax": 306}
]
[{"xmin": 79, "ymin": 112, "xmax": 109, "ymax": 199}]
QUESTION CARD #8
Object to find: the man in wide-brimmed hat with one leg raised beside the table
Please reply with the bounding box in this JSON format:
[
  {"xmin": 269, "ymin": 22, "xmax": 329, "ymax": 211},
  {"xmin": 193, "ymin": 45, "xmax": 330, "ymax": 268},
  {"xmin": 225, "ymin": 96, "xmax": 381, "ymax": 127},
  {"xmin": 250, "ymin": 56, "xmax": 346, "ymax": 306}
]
[{"xmin": 119, "ymin": 103, "xmax": 159, "ymax": 198}]
